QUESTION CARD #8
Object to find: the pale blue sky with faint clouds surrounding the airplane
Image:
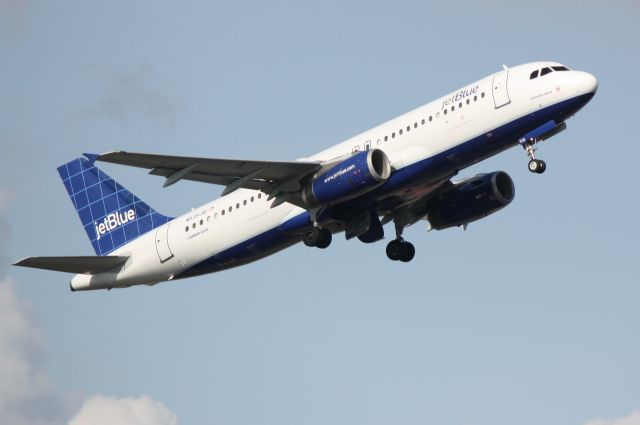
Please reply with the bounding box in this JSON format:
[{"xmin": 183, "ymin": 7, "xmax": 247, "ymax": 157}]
[{"xmin": 0, "ymin": 0, "xmax": 640, "ymax": 425}]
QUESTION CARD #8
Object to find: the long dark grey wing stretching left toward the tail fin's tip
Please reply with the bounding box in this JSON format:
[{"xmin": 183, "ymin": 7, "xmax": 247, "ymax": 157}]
[{"xmin": 94, "ymin": 151, "xmax": 322, "ymax": 195}]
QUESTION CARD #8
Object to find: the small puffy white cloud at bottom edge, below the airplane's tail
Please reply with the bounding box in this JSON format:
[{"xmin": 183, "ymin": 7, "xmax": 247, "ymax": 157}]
[{"xmin": 69, "ymin": 396, "xmax": 178, "ymax": 425}]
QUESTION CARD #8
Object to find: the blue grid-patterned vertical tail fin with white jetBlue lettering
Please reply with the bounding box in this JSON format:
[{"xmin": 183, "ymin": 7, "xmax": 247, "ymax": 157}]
[{"xmin": 58, "ymin": 154, "xmax": 172, "ymax": 255}]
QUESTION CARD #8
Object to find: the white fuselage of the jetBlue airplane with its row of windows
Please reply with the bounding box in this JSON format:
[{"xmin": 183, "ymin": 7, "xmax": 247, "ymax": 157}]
[{"xmin": 71, "ymin": 62, "xmax": 597, "ymax": 290}]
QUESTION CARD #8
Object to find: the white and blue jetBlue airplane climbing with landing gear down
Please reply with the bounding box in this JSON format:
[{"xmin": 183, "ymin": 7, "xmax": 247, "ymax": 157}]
[{"xmin": 14, "ymin": 62, "xmax": 598, "ymax": 291}]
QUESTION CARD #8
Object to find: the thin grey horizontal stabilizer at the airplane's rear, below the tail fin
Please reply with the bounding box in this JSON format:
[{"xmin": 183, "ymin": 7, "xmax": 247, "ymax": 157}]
[{"xmin": 13, "ymin": 256, "xmax": 129, "ymax": 274}]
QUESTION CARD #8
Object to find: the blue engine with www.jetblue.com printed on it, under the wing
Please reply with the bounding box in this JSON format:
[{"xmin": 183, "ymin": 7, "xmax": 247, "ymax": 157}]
[{"xmin": 303, "ymin": 149, "xmax": 391, "ymax": 205}]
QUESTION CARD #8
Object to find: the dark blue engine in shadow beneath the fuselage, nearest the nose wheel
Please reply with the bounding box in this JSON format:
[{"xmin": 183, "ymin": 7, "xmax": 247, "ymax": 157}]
[{"xmin": 427, "ymin": 171, "xmax": 515, "ymax": 230}]
